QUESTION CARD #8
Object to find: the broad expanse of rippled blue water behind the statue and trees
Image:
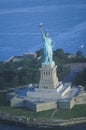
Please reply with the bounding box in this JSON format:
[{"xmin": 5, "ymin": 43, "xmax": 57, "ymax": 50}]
[{"xmin": 0, "ymin": 0, "xmax": 86, "ymax": 60}]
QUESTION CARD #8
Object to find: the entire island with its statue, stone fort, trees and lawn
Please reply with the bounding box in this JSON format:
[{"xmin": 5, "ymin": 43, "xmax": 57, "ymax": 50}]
[{"xmin": 0, "ymin": 24, "xmax": 86, "ymax": 127}]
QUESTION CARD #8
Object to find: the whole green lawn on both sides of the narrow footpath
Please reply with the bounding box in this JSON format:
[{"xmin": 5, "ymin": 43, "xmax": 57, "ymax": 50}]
[{"xmin": 0, "ymin": 104, "xmax": 86, "ymax": 119}]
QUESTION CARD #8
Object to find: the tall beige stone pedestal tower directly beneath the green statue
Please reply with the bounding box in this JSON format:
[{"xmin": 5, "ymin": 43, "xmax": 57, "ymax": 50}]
[{"xmin": 39, "ymin": 63, "xmax": 58, "ymax": 89}]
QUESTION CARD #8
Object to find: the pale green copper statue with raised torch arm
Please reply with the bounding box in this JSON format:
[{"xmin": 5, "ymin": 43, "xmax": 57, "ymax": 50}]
[{"xmin": 40, "ymin": 23, "xmax": 54, "ymax": 64}]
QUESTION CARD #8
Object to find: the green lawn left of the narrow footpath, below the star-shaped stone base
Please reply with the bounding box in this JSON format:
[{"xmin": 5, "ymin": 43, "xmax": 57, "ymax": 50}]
[{"xmin": 0, "ymin": 106, "xmax": 53, "ymax": 119}]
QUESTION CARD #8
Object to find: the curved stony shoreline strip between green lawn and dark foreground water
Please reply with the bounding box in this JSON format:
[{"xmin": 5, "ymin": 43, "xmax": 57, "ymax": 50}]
[{"xmin": 0, "ymin": 113, "xmax": 86, "ymax": 127}]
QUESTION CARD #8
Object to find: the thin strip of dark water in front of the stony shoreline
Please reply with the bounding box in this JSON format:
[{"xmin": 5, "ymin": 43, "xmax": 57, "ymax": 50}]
[{"xmin": 0, "ymin": 123, "xmax": 86, "ymax": 130}]
